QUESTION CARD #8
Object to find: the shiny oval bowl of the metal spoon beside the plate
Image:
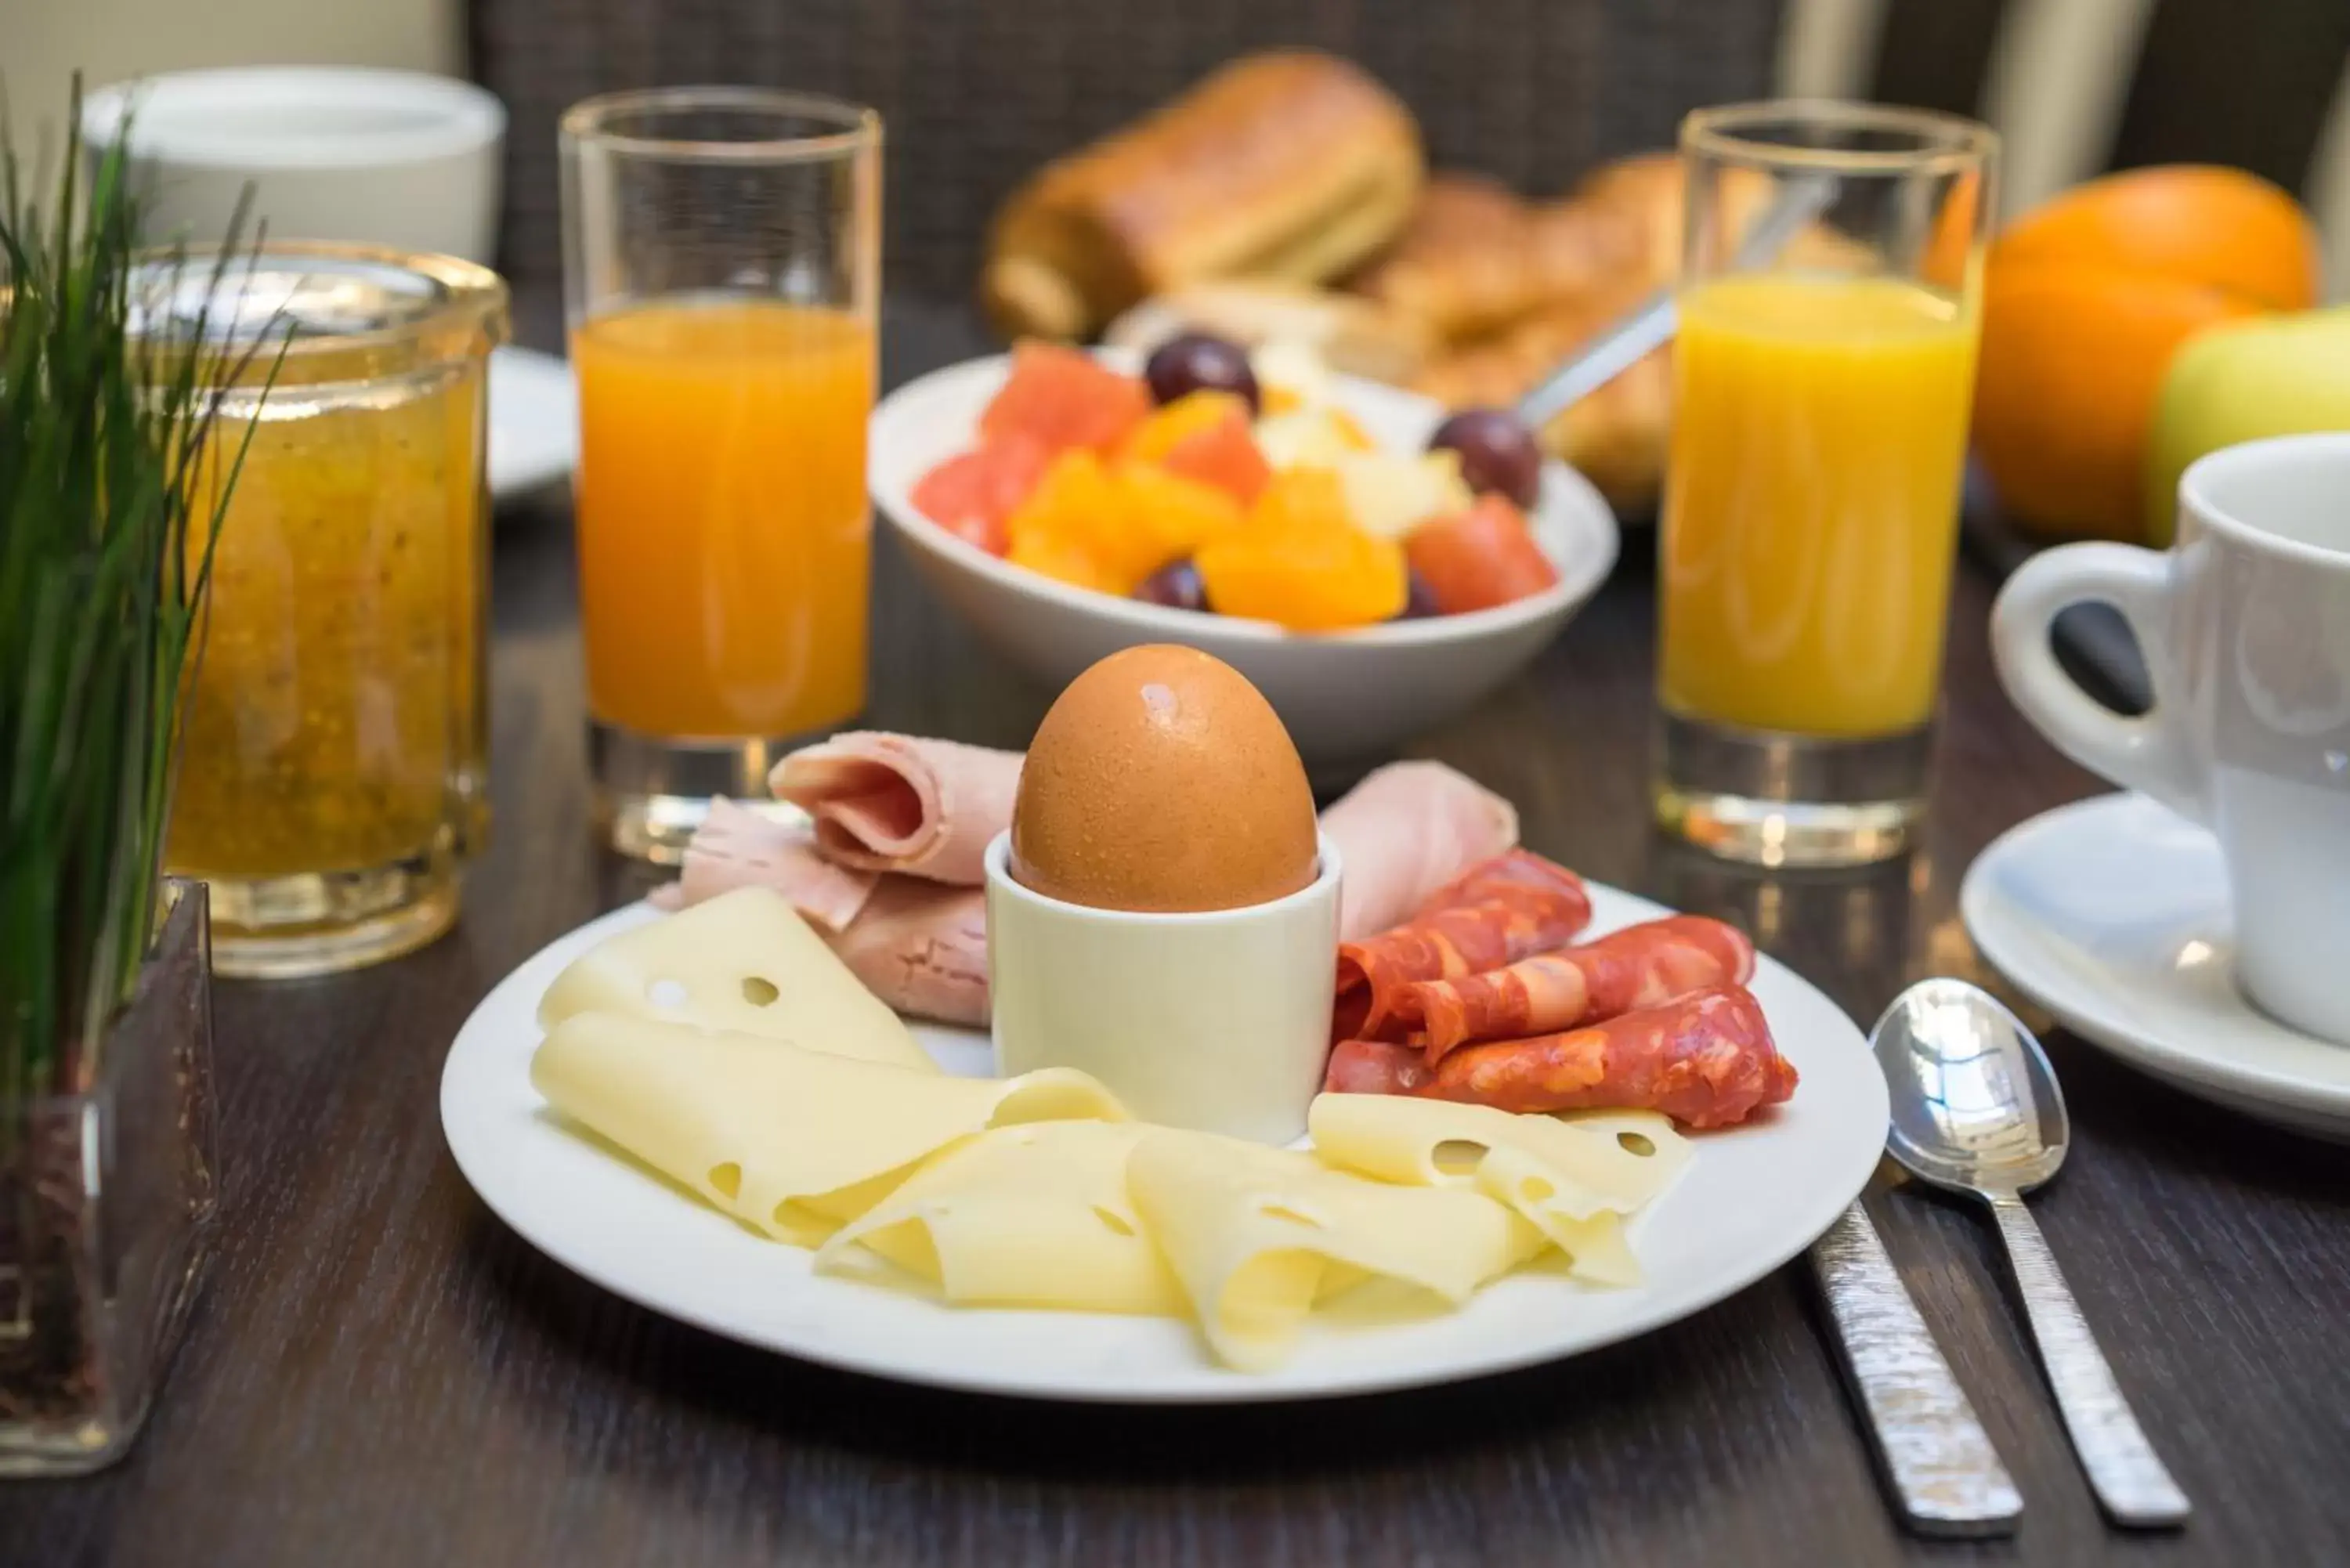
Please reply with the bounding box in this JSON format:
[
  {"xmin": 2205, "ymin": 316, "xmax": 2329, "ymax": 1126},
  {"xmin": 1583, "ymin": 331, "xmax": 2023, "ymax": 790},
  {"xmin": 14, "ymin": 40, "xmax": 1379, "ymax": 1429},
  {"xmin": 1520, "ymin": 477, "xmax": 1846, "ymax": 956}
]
[{"xmin": 1868, "ymin": 981, "xmax": 2070, "ymax": 1197}]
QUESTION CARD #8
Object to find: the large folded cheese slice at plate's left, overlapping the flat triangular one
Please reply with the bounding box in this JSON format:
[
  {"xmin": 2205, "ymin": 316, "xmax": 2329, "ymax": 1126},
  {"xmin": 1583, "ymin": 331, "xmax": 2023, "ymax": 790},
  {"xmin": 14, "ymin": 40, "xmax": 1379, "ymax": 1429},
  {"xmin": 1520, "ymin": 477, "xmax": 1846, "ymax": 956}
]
[{"xmin": 531, "ymin": 1013, "xmax": 1126, "ymax": 1246}]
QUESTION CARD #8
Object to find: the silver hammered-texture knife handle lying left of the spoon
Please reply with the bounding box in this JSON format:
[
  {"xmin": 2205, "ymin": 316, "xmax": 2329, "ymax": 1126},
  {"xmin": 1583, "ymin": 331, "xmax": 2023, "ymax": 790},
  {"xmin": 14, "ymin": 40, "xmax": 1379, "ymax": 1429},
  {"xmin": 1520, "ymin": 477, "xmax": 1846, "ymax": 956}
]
[{"xmin": 1810, "ymin": 1201, "xmax": 2023, "ymax": 1535}]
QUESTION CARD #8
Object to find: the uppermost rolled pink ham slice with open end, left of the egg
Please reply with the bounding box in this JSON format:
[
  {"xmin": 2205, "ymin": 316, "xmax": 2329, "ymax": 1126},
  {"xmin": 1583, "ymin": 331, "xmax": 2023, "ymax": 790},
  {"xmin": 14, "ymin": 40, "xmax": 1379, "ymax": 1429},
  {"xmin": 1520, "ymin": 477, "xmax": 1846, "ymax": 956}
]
[{"xmin": 766, "ymin": 728, "xmax": 1020, "ymax": 887}]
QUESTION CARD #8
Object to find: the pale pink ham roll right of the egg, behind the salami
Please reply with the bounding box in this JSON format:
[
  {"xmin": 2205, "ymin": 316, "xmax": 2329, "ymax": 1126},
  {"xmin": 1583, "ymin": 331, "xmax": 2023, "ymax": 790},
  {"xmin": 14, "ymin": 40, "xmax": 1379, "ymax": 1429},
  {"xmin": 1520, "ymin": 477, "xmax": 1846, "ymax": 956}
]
[{"xmin": 1321, "ymin": 761, "xmax": 1518, "ymax": 943}]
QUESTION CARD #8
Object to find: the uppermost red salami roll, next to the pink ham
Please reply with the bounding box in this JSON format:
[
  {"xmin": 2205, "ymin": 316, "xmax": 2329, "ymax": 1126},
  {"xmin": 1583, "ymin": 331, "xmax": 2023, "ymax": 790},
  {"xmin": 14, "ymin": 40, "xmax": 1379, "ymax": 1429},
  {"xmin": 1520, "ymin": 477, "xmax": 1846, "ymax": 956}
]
[{"xmin": 1335, "ymin": 849, "xmax": 1591, "ymax": 1039}]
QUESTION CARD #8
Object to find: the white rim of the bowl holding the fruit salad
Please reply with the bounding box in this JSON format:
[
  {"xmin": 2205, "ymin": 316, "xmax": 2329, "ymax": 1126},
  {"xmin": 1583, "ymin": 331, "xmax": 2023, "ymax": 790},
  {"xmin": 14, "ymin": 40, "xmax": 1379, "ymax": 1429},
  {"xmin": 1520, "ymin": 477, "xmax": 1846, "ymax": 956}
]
[{"xmin": 867, "ymin": 348, "xmax": 1624, "ymax": 646}]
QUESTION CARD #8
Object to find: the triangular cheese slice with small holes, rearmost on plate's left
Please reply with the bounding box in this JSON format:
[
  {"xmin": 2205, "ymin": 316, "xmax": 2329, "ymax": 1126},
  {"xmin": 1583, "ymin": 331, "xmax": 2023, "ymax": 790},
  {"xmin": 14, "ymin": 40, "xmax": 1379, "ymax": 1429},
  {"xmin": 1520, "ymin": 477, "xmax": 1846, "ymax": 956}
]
[{"xmin": 538, "ymin": 887, "xmax": 938, "ymax": 1072}]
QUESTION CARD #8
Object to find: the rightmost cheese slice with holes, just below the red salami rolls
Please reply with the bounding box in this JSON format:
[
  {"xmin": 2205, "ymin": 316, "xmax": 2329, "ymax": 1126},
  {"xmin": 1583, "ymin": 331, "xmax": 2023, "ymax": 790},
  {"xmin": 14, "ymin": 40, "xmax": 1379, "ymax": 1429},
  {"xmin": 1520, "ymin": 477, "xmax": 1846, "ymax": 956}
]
[{"xmin": 1307, "ymin": 1096, "xmax": 1690, "ymax": 1286}]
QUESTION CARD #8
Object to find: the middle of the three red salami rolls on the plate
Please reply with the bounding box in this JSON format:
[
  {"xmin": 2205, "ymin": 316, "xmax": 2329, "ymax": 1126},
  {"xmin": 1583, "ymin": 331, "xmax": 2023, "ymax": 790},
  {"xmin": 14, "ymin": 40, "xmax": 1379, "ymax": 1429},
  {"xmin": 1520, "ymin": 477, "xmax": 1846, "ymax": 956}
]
[{"xmin": 1396, "ymin": 915, "xmax": 1755, "ymax": 1063}]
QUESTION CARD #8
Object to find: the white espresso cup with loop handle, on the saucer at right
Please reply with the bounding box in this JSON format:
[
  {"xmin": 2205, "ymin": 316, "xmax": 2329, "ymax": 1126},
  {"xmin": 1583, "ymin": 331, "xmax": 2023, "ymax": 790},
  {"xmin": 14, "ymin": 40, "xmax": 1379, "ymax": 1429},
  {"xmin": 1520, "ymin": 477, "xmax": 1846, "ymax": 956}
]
[{"xmin": 1990, "ymin": 432, "xmax": 2350, "ymax": 1044}]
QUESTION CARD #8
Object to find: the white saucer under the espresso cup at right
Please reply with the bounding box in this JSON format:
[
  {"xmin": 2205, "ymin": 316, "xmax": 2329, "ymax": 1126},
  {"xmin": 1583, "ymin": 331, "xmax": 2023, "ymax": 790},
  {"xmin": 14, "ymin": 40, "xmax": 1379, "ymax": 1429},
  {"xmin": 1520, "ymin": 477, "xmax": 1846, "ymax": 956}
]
[{"xmin": 1958, "ymin": 795, "xmax": 2350, "ymax": 1143}]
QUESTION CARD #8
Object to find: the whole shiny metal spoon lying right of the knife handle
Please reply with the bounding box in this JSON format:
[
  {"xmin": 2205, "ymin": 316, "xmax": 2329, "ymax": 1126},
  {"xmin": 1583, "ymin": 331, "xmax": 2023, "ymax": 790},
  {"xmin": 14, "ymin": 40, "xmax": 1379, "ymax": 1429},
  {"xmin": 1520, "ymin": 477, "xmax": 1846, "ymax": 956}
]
[{"xmin": 1868, "ymin": 981, "xmax": 2188, "ymax": 1526}]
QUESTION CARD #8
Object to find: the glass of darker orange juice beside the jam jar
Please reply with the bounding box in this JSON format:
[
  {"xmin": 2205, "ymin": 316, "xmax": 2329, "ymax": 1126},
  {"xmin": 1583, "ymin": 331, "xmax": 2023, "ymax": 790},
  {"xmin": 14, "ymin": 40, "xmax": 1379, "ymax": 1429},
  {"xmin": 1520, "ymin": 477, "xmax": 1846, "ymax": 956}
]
[{"xmin": 562, "ymin": 87, "xmax": 881, "ymax": 861}]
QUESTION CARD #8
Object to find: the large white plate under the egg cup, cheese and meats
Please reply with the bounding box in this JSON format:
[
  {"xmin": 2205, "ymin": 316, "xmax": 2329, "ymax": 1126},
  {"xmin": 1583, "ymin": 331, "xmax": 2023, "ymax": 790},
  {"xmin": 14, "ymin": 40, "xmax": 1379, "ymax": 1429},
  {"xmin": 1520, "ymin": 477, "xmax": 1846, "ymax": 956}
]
[{"xmin": 442, "ymin": 887, "xmax": 1885, "ymax": 1404}]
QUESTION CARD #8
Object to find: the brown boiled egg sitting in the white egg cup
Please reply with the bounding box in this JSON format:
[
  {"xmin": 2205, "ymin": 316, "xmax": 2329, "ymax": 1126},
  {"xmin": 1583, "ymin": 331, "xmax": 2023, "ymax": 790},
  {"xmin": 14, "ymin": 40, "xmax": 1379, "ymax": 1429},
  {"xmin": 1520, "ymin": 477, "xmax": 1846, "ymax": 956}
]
[{"xmin": 1010, "ymin": 644, "xmax": 1318, "ymax": 912}]
